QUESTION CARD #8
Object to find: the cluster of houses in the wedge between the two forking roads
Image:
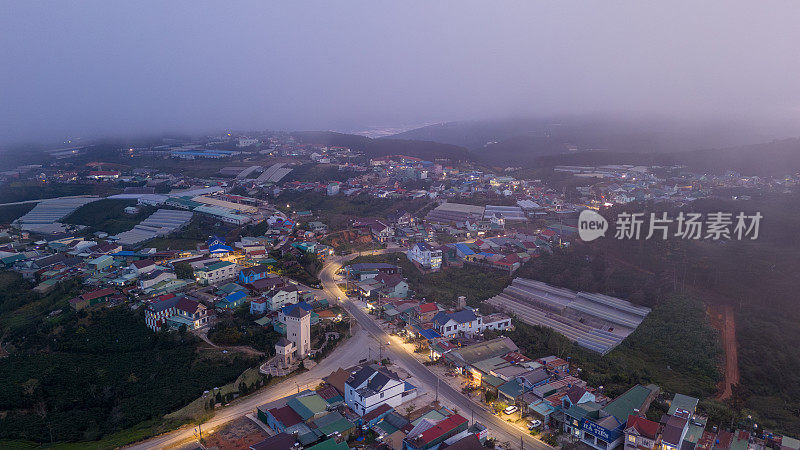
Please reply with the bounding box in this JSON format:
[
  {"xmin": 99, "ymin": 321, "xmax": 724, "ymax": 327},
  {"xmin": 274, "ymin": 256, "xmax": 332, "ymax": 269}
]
[{"xmin": 251, "ymin": 363, "xmax": 487, "ymax": 450}]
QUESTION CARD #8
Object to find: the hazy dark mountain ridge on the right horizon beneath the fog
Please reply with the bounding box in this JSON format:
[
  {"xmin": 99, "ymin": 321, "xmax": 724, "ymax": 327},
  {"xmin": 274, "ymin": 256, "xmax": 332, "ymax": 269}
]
[{"xmin": 382, "ymin": 117, "xmax": 800, "ymax": 175}]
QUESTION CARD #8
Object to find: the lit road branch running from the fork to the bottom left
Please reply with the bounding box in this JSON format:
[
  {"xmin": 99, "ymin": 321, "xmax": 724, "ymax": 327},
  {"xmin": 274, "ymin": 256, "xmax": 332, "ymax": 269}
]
[{"xmin": 128, "ymin": 325, "xmax": 375, "ymax": 450}]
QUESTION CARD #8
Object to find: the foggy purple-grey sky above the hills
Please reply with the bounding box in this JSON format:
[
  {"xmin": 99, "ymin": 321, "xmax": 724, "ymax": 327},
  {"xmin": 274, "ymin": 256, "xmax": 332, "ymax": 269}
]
[{"xmin": 0, "ymin": 0, "xmax": 800, "ymax": 143}]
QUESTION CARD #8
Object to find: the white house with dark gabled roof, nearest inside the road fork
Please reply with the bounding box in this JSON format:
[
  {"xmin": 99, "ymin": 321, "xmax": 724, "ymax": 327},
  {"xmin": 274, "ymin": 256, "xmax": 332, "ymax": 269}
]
[{"xmin": 344, "ymin": 366, "xmax": 417, "ymax": 416}]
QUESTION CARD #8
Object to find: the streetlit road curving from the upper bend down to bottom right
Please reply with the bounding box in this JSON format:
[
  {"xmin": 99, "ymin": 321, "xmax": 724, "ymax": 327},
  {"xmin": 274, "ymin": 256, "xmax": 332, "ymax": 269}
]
[{"xmin": 319, "ymin": 253, "xmax": 551, "ymax": 449}]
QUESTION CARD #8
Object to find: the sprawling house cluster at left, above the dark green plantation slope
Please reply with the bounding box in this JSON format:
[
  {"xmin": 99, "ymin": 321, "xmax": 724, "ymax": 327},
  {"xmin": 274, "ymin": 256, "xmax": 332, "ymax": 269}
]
[{"xmin": 0, "ymin": 221, "xmax": 341, "ymax": 342}]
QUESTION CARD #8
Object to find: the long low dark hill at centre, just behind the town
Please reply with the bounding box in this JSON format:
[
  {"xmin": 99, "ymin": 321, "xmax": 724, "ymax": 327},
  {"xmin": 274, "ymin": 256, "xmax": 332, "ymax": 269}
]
[{"xmin": 291, "ymin": 131, "xmax": 474, "ymax": 161}]
